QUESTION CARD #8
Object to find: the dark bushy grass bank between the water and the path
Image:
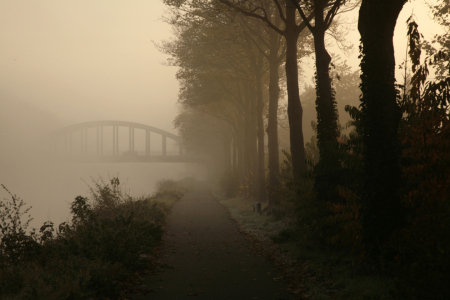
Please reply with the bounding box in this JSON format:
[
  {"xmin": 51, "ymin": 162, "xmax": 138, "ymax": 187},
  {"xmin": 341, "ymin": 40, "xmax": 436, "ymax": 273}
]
[{"xmin": 0, "ymin": 178, "xmax": 192, "ymax": 300}]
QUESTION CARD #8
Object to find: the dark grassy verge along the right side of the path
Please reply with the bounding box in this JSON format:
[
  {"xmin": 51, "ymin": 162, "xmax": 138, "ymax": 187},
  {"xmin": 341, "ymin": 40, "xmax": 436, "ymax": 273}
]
[{"xmin": 215, "ymin": 192, "xmax": 402, "ymax": 300}]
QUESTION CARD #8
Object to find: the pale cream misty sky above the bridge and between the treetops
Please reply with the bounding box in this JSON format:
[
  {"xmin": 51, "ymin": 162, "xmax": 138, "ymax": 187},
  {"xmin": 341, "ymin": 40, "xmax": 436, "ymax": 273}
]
[{"xmin": 0, "ymin": 0, "xmax": 442, "ymax": 132}]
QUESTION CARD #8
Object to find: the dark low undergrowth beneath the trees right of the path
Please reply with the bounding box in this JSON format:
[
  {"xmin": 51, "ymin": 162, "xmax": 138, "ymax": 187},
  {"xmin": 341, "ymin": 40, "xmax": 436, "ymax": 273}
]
[{"xmin": 217, "ymin": 139, "xmax": 449, "ymax": 300}]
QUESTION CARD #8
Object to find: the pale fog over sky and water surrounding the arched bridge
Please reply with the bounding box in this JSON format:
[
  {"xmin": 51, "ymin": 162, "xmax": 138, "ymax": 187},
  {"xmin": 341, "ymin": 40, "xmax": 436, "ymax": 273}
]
[{"xmin": 0, "ymin": 0, "xmax": 197, "ymax": 227}]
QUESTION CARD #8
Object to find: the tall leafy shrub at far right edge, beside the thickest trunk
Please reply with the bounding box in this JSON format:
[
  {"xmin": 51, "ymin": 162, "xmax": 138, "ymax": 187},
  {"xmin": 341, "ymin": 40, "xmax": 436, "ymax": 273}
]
[{"xmin": 399, "ymin": 16, "xmax": 450, "ymax": 299}]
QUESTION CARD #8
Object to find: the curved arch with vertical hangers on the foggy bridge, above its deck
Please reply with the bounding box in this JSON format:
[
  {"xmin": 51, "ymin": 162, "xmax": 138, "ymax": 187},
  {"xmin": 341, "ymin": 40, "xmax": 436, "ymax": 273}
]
[{"xmin": 47, "ymin": 120, "xmax": 191, "ymax": 161}]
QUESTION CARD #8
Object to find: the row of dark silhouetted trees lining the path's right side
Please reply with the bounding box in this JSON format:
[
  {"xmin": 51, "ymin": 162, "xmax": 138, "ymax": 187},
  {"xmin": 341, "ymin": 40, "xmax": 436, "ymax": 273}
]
[{"xmin": 161, "ymin": 0, "xmax": 450, "ymax": 298}]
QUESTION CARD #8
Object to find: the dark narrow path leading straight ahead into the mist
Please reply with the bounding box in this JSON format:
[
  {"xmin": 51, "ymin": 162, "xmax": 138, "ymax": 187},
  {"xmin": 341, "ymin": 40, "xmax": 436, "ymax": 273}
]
[{"xmin": 133, "ymin": 188, "xmax": 291, "ymax": 300}]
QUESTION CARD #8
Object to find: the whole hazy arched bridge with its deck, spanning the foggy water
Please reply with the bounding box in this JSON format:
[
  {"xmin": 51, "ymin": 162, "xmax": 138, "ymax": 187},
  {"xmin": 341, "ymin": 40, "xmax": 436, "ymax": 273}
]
[{"xmin": 47, "ymin": 121, "xmax": 204, "ymax": 163}]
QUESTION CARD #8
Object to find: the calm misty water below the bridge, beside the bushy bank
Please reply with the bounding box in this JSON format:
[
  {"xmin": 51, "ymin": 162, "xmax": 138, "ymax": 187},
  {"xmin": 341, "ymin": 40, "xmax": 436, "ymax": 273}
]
[{"xmin": 0, "ymin": 158, "xmax": 193, "ymax": 228}]
